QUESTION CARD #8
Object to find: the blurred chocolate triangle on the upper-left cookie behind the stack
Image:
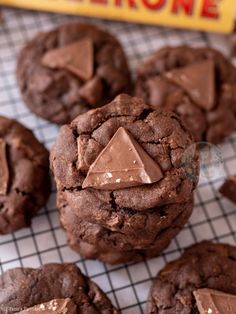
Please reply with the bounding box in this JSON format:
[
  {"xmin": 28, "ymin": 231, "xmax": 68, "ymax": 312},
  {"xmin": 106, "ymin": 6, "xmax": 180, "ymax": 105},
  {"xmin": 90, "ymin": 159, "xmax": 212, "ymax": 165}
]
[{"xmin": 42, "ymin": 38, "xmax": 94, "ymax": 81}]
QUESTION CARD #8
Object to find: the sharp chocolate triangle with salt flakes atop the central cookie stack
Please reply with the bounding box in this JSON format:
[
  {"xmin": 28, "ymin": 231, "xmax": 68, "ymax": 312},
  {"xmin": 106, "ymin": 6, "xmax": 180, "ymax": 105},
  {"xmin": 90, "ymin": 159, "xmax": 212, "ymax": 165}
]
[{"xmin": 82, "ymin": 127, "xmax": 163, "ymax": 190}]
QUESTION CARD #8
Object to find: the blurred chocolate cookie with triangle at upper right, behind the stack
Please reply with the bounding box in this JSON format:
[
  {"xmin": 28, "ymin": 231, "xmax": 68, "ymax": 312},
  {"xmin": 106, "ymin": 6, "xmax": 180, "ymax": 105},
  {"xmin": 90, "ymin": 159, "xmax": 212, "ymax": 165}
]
[{"xmin": 135, "ymin": 46, "xmax": 236, "ymax": 143}]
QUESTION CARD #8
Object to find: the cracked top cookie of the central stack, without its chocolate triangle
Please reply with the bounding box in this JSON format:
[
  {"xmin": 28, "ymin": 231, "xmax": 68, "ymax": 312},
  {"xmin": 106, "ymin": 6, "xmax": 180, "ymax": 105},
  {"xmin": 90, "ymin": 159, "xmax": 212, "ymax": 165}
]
[{"xmin": 50, "ymin": 95, "xmax": 199, "ymax": 212}]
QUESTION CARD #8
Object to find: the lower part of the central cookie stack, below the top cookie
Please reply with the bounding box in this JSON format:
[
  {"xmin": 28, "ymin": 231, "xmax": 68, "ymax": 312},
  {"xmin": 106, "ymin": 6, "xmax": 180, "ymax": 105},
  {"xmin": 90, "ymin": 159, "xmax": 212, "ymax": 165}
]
[{"xmin": 58, "ymin": 195, "xmax": 193, "ymax": 264}]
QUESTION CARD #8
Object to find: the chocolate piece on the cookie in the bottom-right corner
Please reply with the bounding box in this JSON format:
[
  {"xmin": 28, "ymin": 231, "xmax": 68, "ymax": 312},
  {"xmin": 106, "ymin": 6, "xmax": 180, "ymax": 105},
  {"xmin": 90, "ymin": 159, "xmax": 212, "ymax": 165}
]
[{"xmin": 193, "ymin": 289, "xmax": 236, "ymax": 314}]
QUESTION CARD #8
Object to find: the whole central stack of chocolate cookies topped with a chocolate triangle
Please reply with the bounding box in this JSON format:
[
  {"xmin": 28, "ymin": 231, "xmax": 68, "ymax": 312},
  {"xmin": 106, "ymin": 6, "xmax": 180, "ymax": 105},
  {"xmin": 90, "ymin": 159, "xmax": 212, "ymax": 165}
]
[{"xmin": 51, "ymin": 95, "xmax": 199, "ymax": 264}]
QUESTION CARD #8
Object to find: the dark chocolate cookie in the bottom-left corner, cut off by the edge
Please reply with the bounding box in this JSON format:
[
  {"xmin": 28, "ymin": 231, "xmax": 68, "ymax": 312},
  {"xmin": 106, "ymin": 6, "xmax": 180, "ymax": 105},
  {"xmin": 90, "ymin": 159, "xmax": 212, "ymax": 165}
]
[{"xmin": 0, "ymin": 264, "xmax": 118, "ymax": 314}]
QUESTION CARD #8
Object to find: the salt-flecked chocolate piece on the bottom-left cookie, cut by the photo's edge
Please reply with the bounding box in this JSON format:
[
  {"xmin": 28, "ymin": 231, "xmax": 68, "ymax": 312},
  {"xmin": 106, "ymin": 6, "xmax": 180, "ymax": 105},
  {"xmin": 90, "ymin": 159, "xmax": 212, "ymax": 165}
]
[{"xmin": 18, "ymin": 298, "xmax": 77, "ymax": 314}]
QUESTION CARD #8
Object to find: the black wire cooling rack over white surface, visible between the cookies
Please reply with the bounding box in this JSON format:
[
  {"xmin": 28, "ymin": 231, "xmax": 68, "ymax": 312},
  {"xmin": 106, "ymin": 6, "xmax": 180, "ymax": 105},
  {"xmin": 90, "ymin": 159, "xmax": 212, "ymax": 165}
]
[{"xmin": 0, "ymin": 9, "xmax": 236, "ymax": 314}]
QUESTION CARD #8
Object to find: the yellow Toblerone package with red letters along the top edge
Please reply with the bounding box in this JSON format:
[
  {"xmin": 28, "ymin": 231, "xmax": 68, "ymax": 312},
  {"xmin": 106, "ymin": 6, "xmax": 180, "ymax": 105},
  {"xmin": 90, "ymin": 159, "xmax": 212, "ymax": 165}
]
[{"xmin": 0, "ymin": 0, "xmax": 236, "ymax": 33}]
